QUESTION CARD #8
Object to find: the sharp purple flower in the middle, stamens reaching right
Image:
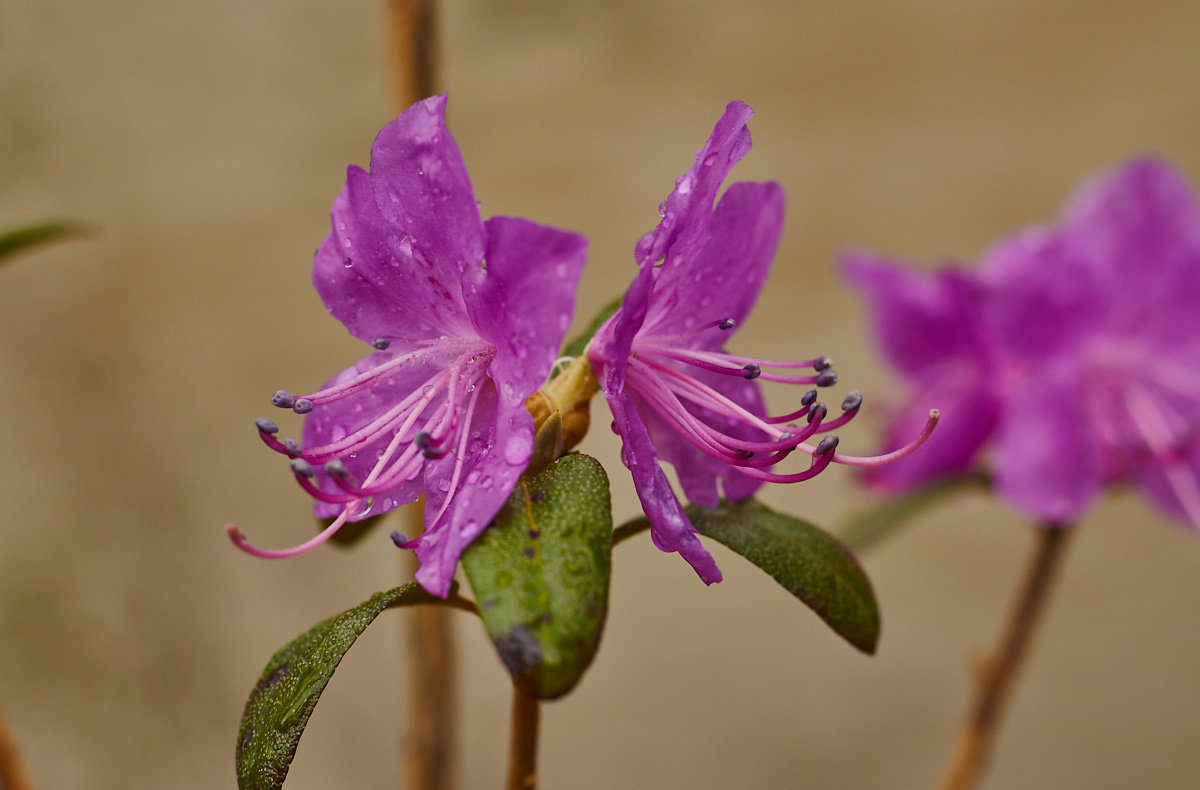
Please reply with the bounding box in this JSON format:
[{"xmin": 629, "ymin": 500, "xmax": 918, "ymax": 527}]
[{"xmin": 588, "ymin": 102, "xmax": 936, "ymax": 583}]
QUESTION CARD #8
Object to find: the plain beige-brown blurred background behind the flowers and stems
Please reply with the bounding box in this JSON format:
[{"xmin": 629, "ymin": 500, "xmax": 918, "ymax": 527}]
[{"xmin": 0, "ymin": 0, "xmax": 1200, "ymax": 790}]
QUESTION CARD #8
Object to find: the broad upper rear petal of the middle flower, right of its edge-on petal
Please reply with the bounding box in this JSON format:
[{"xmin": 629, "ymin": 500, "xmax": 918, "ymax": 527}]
[{"xmin": 642, "ymin": 181, "xmax": 784, "ymax": 340}]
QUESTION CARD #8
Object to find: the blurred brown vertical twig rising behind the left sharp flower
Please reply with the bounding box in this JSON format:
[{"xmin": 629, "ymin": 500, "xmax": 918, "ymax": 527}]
[{"xmin": 384, "ymin": 0, "xmax": 455, "ymax": 790}]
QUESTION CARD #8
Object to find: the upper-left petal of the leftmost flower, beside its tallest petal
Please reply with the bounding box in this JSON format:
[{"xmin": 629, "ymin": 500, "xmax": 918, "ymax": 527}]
[{"xmin": 312, "ymin": 167, "xmax": 478, "ymax": 342}]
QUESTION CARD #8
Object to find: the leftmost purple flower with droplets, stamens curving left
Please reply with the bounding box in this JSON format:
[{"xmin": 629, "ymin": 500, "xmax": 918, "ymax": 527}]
[{"xmin": 230, "ymin": 96, "xmax": 587, "ymax": 596}]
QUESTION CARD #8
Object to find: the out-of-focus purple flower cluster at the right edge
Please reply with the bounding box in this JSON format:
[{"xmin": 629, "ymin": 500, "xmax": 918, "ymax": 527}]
[{"xmin": 844, "ymin": 160, "xmax": 1200, "ymax": 526}]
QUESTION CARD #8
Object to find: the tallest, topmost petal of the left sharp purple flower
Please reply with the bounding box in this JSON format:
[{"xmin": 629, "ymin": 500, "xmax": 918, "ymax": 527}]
[{"xmin": 371, "ymin": 95, "xmax": 485, "ymax": 304}]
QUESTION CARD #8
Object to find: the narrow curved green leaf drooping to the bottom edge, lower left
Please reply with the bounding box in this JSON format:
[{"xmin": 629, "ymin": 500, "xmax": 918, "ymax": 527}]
[{"xmin": 236, "ymin": 581, "xmax": 456, "ymax": 790}]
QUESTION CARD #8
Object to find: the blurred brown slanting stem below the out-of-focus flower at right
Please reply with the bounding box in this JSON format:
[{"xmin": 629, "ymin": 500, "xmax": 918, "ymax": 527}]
[{"xmin": 938, "ymin": 525, "xmax": 1073, "ymax": 790}]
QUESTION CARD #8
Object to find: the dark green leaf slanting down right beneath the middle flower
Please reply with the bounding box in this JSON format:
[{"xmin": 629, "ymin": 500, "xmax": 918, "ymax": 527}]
[{"xmin": 616, "ymin": 499, "xmax": 880, "ymax": 653}]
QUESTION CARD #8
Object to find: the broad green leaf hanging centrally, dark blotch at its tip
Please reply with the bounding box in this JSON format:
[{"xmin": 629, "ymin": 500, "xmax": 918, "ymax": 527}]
[{"xmin": 462, "ymin": 454, "xmax": 612, "ymax": 700}]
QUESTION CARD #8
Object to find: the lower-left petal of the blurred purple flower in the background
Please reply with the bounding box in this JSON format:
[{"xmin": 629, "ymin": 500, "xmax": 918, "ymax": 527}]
[{"xmin": 864, "ymin": 360, "xmax": 1001, "ymax": 493}]
